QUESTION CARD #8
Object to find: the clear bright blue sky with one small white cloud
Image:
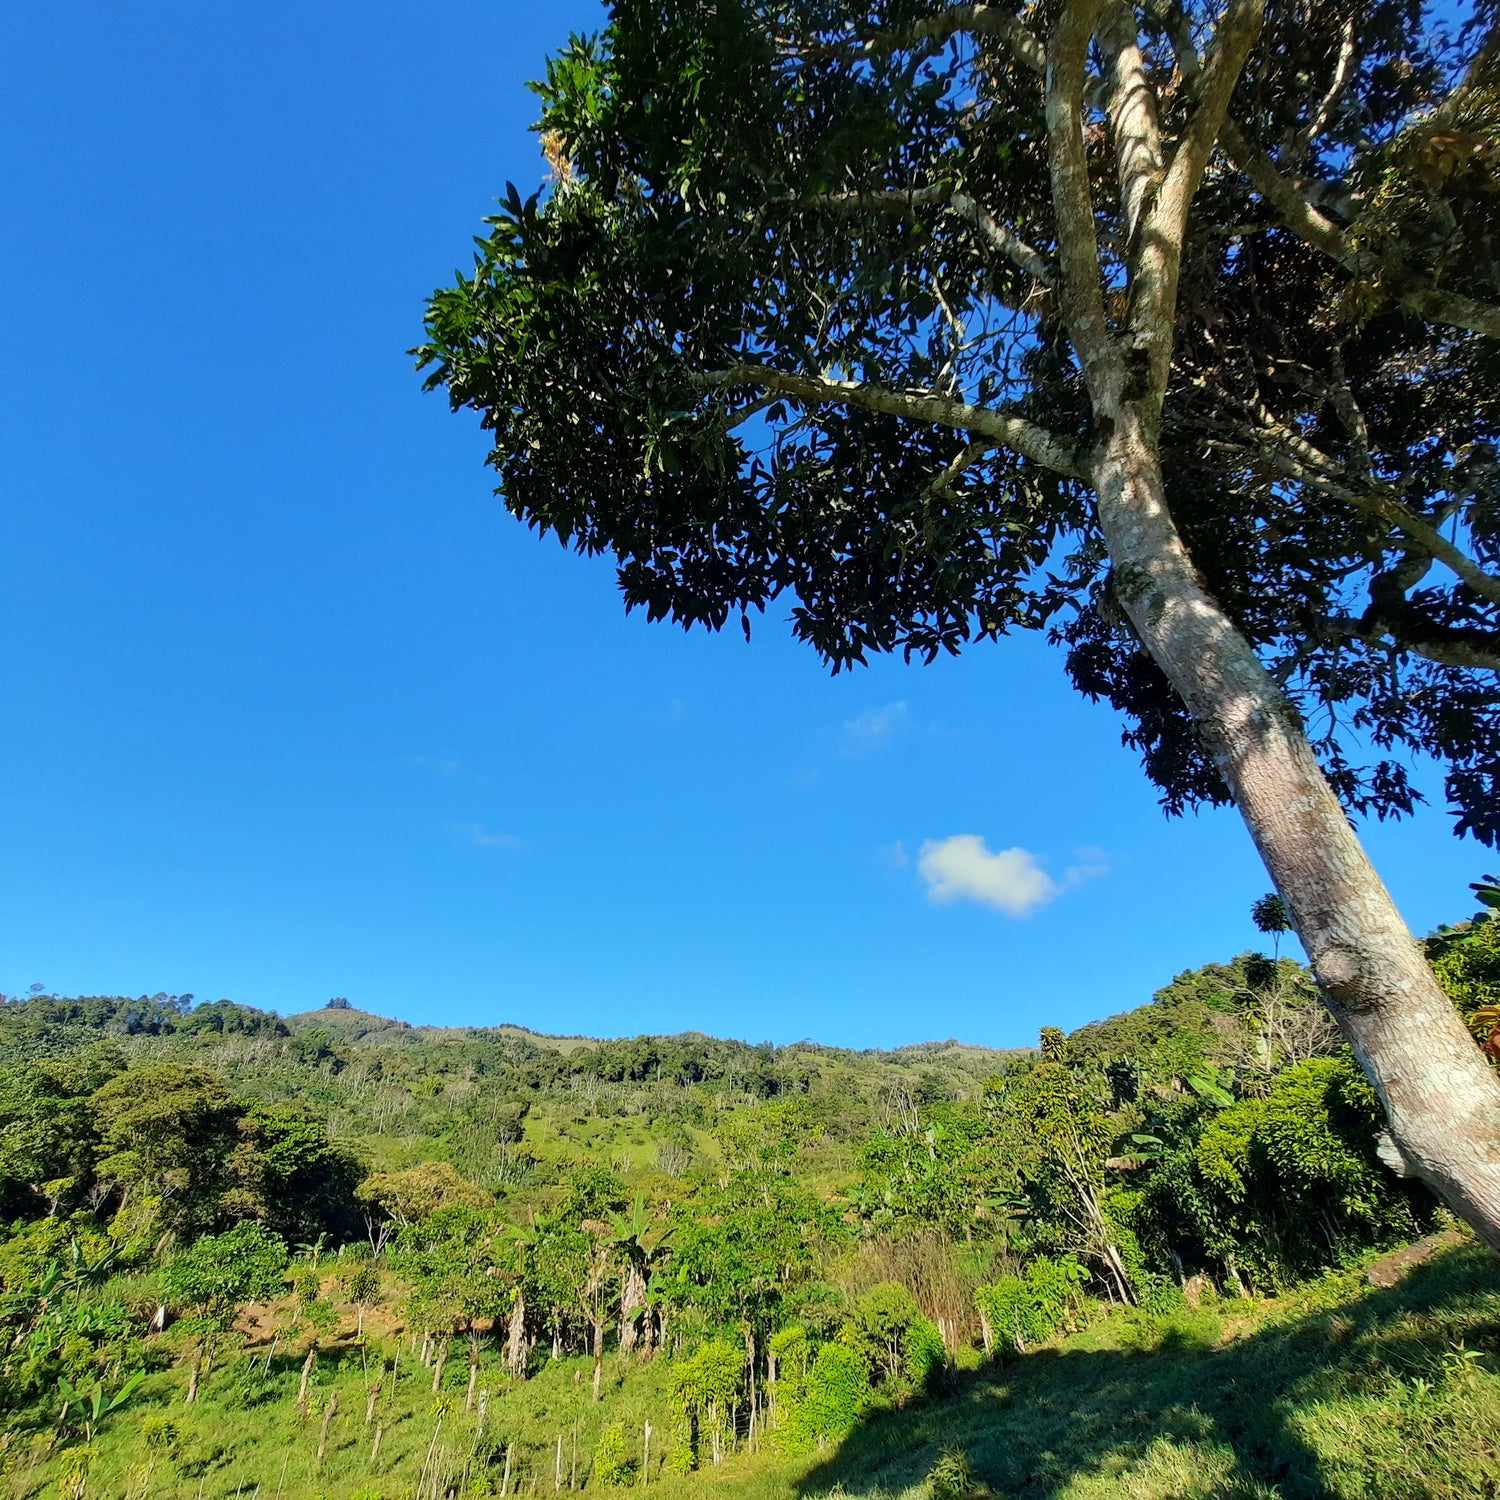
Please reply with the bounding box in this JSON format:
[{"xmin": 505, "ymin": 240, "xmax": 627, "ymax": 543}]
[{"xmin": 0, "ymin": 0, "xmax": 1493, "ymax": 1046}]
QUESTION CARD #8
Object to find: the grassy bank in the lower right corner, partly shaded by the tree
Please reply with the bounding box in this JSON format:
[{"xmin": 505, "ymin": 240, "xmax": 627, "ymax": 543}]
[{"xmin": 798, "ymin": 1247, "xmax": 1500, "ymax": 1500}]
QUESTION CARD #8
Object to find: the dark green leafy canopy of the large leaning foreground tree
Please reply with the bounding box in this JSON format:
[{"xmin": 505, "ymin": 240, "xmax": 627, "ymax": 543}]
[{"xmin": 414, "ymin": 0, "xmax": 1500, "ymax": 842}]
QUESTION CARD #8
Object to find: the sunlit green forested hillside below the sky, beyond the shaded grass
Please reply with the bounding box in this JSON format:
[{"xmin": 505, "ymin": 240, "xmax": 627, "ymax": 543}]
[{"xmin": 0, "ymin": 887, "xmax": 1500, "ymax": 1500}]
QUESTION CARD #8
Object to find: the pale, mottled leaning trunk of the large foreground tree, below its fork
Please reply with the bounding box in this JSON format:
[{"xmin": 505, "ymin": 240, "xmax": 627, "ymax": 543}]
[{"xmin": 1094, "ymin": 405, "xmax": 1500, "ymax": 1250}]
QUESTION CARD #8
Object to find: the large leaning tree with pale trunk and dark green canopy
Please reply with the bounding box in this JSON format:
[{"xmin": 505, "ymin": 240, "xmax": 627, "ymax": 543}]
[{"xmin": 417, "ymin": 0, "xmax": 1500, "ymax": 1247}]
